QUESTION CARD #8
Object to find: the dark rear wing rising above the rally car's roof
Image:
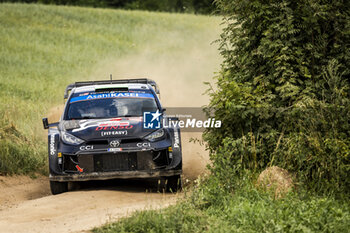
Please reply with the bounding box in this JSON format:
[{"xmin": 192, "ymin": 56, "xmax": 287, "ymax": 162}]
[{"xmin": 64, "ymin": 78, "xmax": 160, "ymax": 99}]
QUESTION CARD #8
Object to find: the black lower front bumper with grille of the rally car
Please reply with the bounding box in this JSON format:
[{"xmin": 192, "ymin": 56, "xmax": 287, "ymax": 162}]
[{"xmin": 49, "ymin": 148, "xmax": 182, "ymax": 181}]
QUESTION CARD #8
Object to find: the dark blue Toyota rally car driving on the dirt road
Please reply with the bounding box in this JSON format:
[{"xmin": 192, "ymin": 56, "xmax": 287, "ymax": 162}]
[{"xmin": 43, "ymin": 79, "xmax": 182, "ymax": 194}]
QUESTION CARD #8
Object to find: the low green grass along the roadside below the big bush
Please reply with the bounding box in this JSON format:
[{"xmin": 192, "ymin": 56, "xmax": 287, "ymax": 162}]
[{"xmin": 93, "ymin": 188, "xmax": 350, "ymax": 233}]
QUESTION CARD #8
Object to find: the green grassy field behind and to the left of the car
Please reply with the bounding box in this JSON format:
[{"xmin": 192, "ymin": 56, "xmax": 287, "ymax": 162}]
[{"xmin": 0, "ymin": 3, "xmax": 219, "ymax": 174}]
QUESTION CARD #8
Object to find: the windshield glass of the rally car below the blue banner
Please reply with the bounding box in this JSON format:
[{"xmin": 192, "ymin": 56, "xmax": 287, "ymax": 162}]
[{"xmin": 66, "ymin": 98, "xmax": 158, "ymax": 120}]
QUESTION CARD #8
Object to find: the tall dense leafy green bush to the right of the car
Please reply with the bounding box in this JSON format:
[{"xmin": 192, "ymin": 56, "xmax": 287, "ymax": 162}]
[{"xmin": 204, "ymin": 0, "xmax": 350, "ymax": 196}]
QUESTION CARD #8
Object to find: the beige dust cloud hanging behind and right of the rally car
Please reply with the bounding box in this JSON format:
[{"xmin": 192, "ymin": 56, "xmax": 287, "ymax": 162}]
[{"xmin": 90, "ymin": 37, "xmax": 221, "ymax": 180}]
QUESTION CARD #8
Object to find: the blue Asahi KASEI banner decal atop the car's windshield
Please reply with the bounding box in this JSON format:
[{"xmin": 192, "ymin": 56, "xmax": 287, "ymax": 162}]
[{"xmin": 70, "ymin": 92, "xmax": 154, "ymax": 103}]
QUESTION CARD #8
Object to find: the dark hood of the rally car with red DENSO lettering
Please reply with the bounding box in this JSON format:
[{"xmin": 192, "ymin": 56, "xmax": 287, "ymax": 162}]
[{"xmin": 60, "ymin": 117, "xmax": 154, "ymax": 140}]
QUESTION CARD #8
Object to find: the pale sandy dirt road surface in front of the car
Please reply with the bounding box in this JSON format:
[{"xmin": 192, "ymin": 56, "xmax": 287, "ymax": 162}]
[{"xmin": 0, "ymin": 180, "xmax": 178, "ymax": 232}]
